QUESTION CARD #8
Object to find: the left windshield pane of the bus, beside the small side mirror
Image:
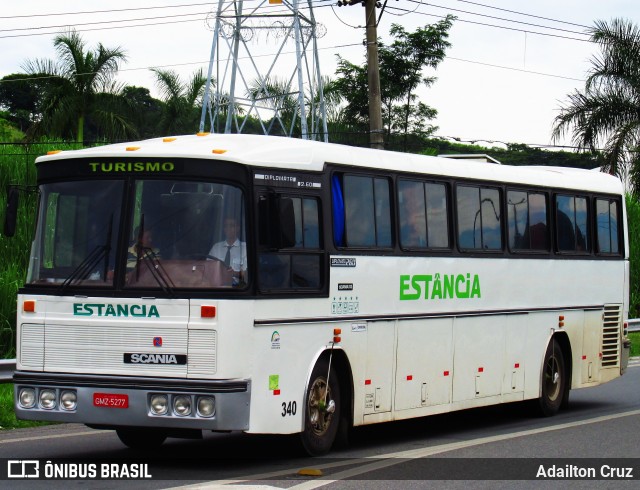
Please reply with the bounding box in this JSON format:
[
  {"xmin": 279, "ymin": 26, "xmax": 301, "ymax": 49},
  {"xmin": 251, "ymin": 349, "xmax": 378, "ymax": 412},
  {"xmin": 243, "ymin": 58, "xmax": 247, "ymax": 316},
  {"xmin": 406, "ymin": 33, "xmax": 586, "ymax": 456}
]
[{"xmin": 27, "ymin": 180, "xmax": 124, "ymax": 287}]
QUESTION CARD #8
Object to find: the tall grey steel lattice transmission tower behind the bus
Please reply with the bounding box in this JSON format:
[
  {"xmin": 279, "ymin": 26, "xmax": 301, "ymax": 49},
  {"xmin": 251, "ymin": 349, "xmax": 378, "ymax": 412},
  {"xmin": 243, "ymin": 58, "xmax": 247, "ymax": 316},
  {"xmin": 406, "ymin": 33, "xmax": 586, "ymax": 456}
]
[{"xmin": 200, "ymin": 0, "xmax": 328, "ymax": 141}]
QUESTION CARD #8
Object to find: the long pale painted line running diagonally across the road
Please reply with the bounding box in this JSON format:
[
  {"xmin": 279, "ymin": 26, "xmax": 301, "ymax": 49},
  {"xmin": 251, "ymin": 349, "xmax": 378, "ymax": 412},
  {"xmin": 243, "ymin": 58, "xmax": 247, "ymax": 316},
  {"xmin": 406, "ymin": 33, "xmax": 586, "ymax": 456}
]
[{"xmin": 173, "ymin": 410, "xmax": 640, "ymax": 490}]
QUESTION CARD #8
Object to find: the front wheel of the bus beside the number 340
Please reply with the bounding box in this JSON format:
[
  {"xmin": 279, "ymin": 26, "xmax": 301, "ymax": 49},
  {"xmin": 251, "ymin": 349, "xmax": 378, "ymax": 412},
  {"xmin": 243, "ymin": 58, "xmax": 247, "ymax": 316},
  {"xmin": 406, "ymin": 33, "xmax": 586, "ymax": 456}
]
[{"xmin": 301, "ymin": 360, "xmax": 340, "ymax": 456}]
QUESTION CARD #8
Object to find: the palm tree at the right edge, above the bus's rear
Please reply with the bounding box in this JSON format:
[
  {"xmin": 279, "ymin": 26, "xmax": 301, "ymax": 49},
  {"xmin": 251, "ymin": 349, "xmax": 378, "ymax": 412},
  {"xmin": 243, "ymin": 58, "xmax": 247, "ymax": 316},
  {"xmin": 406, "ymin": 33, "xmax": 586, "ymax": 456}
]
[{"xmin": 553, "ymin": 19, "xmax": 640, "ymax": 189}]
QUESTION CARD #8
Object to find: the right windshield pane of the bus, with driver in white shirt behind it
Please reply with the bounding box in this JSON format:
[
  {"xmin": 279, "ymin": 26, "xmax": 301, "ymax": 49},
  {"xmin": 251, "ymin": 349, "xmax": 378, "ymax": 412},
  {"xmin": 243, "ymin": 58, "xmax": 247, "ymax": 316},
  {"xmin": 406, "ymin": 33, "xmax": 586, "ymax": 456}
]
[{"xmin": 125, "ymin": 180, "xmax": 248, "ymax": 290}]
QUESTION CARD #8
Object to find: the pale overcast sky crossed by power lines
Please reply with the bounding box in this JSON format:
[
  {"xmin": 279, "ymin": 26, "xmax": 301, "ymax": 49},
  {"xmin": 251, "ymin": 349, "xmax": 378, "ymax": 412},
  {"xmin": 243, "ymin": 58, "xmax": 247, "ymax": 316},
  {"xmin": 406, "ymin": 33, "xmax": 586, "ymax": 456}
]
[{"xmin": 0, "ymin": 0, "xmax": 640, "ymax": 147}]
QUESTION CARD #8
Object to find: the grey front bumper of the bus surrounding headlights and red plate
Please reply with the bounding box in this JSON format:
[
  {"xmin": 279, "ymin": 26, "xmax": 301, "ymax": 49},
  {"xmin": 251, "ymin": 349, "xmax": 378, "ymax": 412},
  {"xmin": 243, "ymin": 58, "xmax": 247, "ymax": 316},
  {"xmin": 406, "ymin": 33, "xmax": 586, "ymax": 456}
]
[{"xmin": 13, "ymin": 371, "xmax": 251, "ymax": 431}]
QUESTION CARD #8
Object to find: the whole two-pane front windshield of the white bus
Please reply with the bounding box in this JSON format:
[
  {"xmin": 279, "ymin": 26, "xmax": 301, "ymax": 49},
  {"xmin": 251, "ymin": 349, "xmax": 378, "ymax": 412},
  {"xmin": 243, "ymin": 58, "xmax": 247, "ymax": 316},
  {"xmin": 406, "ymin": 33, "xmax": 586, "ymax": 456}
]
[{"xmin": 27, "ymin": 179, "xmax": 248, "ymax": 291}]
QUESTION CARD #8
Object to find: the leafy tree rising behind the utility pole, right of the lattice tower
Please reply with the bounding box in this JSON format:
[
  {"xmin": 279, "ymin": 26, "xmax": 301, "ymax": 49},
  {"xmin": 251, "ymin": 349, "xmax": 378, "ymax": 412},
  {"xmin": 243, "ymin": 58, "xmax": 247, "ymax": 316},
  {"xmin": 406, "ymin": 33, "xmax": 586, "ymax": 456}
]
[{"xmin": 327, "ymin": 16, "xmax": 455, "ymax": 147}]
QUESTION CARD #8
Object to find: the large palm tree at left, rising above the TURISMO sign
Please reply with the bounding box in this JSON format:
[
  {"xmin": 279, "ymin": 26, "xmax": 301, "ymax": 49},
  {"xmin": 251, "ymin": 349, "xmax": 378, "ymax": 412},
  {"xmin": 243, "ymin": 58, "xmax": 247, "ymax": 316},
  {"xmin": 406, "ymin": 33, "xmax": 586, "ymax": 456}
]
[{"xmin": 23, "ymin": 30, "xmax": 135, "ymax": 143}]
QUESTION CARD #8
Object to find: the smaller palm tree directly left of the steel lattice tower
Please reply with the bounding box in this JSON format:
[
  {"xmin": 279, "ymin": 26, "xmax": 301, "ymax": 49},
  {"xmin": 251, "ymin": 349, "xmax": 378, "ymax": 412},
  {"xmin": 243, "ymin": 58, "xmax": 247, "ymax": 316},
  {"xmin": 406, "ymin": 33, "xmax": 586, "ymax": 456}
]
[{"xmin": 151, "ymin": 68, "xmax": 207, "ymax": 134}]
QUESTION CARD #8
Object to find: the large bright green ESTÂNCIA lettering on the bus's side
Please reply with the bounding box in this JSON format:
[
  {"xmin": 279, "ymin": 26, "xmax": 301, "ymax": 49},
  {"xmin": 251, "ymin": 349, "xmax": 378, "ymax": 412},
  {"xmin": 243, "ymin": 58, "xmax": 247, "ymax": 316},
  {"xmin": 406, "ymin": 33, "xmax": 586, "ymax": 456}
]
[{"xmin": 400, "ymin": 273, "xmax": 481, "ymax": 300}]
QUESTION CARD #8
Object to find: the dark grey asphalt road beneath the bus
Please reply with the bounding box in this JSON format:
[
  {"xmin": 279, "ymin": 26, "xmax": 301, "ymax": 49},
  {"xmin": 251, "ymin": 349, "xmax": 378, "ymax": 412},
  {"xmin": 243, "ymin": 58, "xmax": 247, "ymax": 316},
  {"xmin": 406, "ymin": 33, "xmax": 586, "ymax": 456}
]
[{"xmin": 0, "ymin": 365, "xmax": 640, "ymax": 490}]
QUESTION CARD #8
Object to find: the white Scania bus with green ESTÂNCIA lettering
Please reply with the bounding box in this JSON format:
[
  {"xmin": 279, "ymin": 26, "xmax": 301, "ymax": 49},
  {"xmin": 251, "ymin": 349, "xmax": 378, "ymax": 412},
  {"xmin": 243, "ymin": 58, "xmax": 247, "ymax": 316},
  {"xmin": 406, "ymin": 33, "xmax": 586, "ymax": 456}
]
[{"xmin": 6, "ymin": 133, "xmax": 629, "ymax": 454}]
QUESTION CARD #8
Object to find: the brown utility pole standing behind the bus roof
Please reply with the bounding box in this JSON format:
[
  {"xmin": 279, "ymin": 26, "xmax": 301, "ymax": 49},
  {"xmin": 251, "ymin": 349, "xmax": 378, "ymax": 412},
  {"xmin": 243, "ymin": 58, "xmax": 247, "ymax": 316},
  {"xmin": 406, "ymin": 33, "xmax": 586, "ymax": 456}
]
[{"xmin": 338, "ymin": 0, "xmax": 386, "ymax": 150}]
